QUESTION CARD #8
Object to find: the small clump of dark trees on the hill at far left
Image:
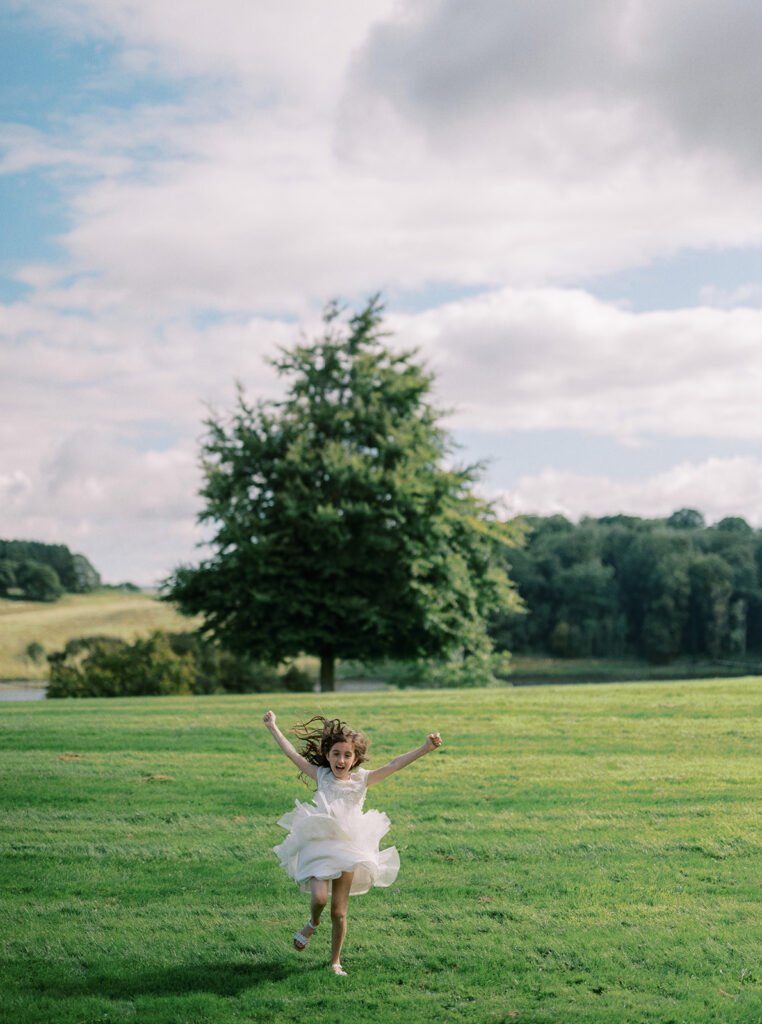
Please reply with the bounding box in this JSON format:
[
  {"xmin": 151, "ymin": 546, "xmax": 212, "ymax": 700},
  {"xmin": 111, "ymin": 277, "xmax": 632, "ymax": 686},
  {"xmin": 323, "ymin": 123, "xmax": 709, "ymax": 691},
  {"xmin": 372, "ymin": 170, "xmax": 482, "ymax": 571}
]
[{"xmin": 0, "ymin": 541, "xmax": 100, "ymax": 601}]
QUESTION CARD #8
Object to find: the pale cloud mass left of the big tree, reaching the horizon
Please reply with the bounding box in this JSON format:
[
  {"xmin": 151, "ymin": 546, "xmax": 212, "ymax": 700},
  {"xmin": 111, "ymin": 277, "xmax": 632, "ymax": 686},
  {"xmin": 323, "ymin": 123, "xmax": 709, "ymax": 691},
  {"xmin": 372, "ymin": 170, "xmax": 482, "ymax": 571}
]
[{"xmin": 0, "ymin": 303, "xmax": 288, "ymax": 583}]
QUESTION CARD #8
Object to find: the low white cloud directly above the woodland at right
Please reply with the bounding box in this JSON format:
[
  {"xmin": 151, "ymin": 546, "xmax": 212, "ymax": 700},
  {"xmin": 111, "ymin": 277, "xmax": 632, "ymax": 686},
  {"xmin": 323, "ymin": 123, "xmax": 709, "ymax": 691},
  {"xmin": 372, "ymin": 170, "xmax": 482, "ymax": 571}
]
[{"xmin": 499, "ymin": 457, "xmax": 762, "ymax": 527}]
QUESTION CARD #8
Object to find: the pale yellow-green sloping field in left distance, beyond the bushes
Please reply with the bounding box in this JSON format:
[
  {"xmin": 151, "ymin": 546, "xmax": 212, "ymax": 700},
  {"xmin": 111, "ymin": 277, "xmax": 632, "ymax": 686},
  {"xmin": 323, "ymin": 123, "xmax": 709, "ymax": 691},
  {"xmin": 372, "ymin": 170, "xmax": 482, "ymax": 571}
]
[{"xmin": 0, "ymin": 591, "xmax": 199, "ymax": 679}]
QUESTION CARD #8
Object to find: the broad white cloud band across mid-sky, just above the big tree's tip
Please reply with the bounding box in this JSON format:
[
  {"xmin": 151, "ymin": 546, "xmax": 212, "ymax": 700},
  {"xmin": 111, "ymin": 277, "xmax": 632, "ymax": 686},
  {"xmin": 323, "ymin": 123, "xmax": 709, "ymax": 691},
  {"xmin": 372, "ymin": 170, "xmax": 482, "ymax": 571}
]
[{"xmin": 8, "ymin": 107, "xmax": 762, "ymax": 316}]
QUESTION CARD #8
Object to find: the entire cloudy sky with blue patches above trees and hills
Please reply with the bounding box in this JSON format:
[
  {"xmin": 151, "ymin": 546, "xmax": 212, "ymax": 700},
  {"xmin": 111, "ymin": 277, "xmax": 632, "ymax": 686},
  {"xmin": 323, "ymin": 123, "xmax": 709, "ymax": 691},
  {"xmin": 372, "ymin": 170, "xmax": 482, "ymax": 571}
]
[{"xmin": 0, "ymin": 0, "xmax": 762, "ymax": 585}]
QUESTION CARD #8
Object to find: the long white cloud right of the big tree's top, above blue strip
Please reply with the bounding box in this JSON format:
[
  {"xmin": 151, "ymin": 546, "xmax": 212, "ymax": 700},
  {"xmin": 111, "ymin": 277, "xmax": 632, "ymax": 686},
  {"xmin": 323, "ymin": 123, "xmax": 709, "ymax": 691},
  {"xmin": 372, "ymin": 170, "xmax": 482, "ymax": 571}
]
[{"xmin": 393, "ymin": 289, "xmax": 762, "ymax": 439}]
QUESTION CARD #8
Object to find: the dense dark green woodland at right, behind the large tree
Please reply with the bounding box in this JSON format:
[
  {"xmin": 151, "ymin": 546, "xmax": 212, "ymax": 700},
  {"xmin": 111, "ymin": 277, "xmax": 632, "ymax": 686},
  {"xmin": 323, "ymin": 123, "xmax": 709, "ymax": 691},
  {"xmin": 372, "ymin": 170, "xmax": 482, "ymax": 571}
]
[{"xmin": 491, "ymin": 509, "xmax": 762, "ymax": 664}]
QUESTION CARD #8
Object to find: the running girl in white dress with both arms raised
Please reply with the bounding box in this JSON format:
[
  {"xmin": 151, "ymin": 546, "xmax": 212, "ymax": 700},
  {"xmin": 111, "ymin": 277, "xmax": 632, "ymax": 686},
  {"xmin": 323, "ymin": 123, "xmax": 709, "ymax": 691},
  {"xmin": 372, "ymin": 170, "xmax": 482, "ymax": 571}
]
[{"xmin": 264, "ymin": 711, "xmax": 441, "ymax": 975}]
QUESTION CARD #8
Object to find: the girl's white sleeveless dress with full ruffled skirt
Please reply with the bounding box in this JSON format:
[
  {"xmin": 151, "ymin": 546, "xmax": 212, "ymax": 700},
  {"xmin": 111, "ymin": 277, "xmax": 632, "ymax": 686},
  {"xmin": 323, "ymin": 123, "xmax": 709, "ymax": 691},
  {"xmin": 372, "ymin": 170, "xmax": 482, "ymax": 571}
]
[{"xmin": 273, "ymin": 768, "xmax": 399, "ymax": 896}]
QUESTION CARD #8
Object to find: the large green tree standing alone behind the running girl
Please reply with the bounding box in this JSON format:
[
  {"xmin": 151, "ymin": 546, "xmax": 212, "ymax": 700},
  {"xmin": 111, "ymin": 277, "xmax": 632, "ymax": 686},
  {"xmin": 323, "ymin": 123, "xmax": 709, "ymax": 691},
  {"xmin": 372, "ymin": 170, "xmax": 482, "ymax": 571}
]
[{"xmin": 165, "ymin": 299, "xmax": 510, "ymax": 689}]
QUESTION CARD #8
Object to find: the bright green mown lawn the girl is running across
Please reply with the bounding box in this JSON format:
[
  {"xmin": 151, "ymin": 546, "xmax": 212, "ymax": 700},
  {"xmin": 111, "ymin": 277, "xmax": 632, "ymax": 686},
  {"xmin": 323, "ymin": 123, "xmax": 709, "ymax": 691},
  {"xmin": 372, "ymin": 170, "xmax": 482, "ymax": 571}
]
[{"xmin": 0, "ymin": 679, "xmax": 762, "ymax": 1024}]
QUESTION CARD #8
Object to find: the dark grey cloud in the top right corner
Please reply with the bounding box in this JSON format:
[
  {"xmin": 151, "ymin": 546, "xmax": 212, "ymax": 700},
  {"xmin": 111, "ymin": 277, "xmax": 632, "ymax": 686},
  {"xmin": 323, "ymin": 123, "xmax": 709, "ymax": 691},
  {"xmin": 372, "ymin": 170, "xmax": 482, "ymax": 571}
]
[{"xmin": 353, "ymin": 0, "xmax": 762, "ymax": 167}]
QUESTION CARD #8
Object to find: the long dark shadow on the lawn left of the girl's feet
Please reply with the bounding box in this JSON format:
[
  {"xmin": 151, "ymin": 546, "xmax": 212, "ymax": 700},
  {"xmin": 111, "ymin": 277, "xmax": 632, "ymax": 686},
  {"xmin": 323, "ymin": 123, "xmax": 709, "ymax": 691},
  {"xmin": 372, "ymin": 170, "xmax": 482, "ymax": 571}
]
[{"xmin": 16, "ymin": 961, "xmax": 311, "ymax": 999}]
